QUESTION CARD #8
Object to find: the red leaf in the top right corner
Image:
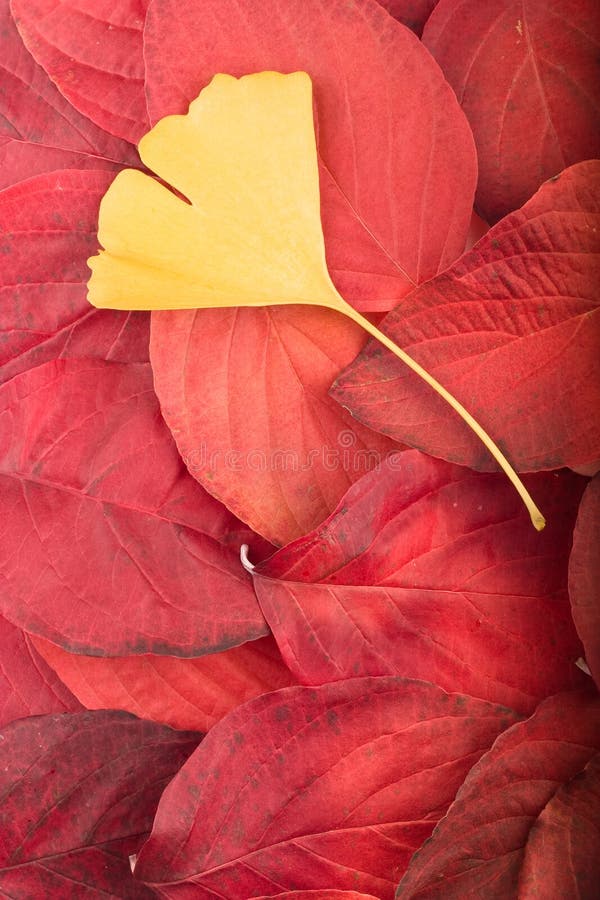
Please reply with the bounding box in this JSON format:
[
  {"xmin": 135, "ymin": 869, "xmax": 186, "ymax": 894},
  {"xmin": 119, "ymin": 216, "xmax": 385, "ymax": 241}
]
[{"xmin": 423, "ymin": 0, "xmax": 600, "ymax": 222}]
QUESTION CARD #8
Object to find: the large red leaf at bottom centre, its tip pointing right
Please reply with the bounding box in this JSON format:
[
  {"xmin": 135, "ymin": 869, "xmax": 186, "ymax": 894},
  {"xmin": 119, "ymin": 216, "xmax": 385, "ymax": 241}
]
[{"xmin": 134, "ymin": 678, "xmax": 512, "ymax": 900}]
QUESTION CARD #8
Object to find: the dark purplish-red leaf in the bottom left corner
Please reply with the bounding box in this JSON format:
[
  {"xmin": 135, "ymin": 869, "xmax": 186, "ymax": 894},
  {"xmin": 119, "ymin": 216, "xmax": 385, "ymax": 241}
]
[{"xmin": 0, "ymin": 711, "xmax": 200, "ymax": 900}]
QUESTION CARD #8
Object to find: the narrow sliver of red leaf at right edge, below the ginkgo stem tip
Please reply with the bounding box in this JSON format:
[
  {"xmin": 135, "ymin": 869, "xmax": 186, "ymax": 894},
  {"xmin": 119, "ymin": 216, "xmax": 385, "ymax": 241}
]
[{"xmin": 569, "ymin": 475, "xmax": 600, "ymax": 686}]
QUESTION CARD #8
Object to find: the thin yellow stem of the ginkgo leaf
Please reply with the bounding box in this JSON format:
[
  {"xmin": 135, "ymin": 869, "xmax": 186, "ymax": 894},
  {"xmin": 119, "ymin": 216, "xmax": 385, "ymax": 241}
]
[{"xmin": 341, "ymin": 302, "xmax": 546, "ymax": 531}]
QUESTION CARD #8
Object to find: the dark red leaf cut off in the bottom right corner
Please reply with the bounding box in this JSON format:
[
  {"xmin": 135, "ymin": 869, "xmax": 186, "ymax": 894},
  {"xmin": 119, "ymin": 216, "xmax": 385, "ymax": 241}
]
[{"xmin": 519, "ymin": 753, "xmax": 600, "ymax": 900}]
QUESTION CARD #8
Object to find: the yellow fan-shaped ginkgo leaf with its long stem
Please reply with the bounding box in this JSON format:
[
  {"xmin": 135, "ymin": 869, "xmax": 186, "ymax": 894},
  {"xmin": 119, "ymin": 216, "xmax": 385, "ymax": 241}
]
[{"xmin": 88, "ymin": 72, "xmax": 545, "ymax": 529}]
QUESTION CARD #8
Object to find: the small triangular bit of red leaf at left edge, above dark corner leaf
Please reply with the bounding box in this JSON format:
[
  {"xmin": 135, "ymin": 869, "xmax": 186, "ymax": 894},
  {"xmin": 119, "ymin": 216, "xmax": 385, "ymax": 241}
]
[{"xmin": 0, "ymin": 617, "xmax": 81, "ymax": 726}]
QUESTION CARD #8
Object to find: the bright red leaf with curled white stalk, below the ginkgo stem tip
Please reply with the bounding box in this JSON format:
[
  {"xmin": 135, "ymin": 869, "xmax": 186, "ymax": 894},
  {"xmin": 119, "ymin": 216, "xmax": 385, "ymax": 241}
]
[{"xmin": 254, "ymin": 450, "xmax": 586, "ymax": 713}]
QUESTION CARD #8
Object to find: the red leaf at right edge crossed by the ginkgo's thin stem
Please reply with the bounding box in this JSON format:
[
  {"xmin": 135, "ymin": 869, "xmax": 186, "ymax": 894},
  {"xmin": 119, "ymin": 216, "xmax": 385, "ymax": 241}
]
[{"xmin": 332, "ymin": 160, "xmax": 600, "ymax": 472}]
